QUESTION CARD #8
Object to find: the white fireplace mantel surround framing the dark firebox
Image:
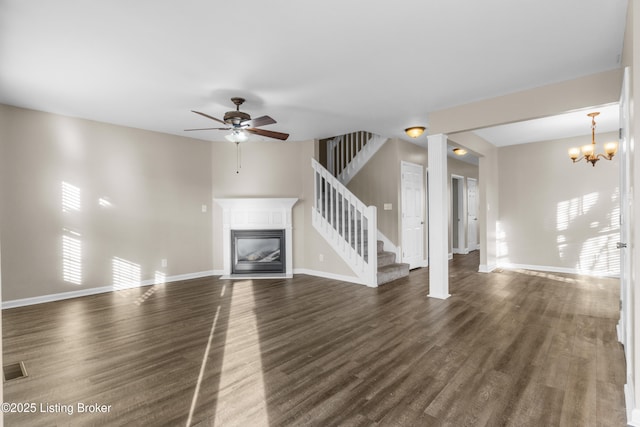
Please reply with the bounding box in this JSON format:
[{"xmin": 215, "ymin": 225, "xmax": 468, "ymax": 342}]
[{"xmin": 214, "ymin": 198, "xmax": 298, "ymax": 279}]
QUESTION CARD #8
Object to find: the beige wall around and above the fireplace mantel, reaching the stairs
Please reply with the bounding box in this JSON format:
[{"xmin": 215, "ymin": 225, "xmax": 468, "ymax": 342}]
[{"xmin": 211, "ymin": 137, "xmax": 355, "ymax": 277}]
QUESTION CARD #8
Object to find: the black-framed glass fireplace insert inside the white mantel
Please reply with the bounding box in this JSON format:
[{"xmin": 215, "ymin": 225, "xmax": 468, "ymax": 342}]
[{"xmin": 231, "ymin": 230, "xmax": 286, "ymax": 274}]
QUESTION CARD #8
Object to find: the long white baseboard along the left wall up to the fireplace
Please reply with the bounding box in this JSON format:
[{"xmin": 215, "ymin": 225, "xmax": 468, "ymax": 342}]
[{"xmin": 2, "ymin": 270, "xmax": 222, "ymax": 310}]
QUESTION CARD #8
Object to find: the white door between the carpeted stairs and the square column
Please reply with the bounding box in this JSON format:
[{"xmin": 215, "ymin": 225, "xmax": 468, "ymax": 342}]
[{"xmin": 401, "ymin": 162, "xmax": 424, "ymax": 268}]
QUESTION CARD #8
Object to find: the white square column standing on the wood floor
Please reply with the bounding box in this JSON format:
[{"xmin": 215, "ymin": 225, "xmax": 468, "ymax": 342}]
[{"xmin": 427, "ymin": 134, "xmax": 451, "ymax": 299}]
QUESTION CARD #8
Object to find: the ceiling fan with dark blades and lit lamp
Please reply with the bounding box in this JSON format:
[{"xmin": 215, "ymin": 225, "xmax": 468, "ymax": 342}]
[{"xmin": 185, "ymin": 97, "xmax": 289, "ymax": 143}]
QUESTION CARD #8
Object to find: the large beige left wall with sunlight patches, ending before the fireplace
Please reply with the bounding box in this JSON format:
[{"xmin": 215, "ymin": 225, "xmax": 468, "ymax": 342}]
[{"xmin": 0, "ymin": 106, "xmax": 212, "ymax": 301}]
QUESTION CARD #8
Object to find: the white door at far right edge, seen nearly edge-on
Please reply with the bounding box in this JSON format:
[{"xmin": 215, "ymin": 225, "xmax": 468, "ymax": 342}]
[{"xmin": 617, "ymin": 67, "xmax": 634, "ymax": 378}]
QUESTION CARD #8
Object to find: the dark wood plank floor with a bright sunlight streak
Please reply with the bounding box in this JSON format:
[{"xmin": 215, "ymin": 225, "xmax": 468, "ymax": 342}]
[{"xmin": 2, "ymin": 252, "xmax": 625, "ymax": 427}]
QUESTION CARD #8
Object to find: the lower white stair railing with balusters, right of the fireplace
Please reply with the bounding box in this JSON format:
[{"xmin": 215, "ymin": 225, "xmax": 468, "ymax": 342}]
[{"xmin": 311, "ymin": 159, "xmax": 378, "ymax": 287}]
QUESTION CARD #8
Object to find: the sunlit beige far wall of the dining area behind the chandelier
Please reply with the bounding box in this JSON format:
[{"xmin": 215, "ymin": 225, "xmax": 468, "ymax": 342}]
[{"xmin": 498, "ymin": 132, "xmax": 620, "ymax": 274}]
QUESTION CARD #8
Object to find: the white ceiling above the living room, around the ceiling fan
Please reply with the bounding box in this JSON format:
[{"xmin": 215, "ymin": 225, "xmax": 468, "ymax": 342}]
[{"xmin": 0, "ymin": 0, "xmax": 627, "ymax": 144}]
